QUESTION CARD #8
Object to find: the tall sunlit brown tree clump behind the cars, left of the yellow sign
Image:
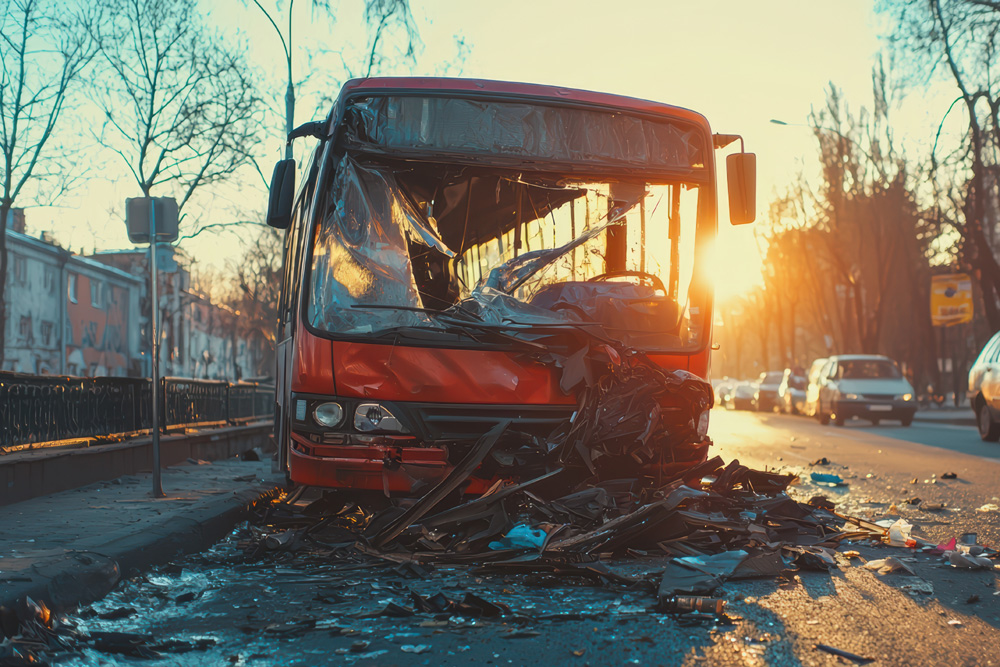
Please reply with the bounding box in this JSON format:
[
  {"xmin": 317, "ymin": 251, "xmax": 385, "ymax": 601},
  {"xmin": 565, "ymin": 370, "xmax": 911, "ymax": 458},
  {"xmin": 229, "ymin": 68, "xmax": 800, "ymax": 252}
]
[{"xmin": 740, "ymin": 67, "xmax": 940, "ymax": 382}]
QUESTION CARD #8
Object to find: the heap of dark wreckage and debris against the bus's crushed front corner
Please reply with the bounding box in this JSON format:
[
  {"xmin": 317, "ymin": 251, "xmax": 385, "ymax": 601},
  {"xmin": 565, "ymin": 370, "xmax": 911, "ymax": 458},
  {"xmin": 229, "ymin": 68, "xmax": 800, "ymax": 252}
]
[{"xmin": 244, "ymin": 344, "xmax": 996, "ymax": 615}]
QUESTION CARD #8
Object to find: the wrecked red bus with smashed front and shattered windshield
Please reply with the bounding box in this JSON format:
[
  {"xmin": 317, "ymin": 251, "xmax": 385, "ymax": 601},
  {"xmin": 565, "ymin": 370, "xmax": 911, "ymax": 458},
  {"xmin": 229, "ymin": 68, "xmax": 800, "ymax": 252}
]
[{"xmin": 268, "ymin": 78, "xmax": 755, "ymax": 494}]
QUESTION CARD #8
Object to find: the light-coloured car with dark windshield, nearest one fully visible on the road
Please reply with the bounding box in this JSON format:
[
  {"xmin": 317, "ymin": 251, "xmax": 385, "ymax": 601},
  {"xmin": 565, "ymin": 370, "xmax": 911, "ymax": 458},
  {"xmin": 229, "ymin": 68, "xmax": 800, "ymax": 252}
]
[{"xmin": 816, "ymin": 354, "xmax": 917, "ymax": 426}]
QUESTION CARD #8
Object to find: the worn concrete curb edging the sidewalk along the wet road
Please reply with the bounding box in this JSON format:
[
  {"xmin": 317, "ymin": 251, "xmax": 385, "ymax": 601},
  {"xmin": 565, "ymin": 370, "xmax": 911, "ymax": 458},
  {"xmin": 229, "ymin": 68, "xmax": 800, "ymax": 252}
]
[{"xmin": 0, "ymin": 482, "xmax": 280, "ymax": 611}]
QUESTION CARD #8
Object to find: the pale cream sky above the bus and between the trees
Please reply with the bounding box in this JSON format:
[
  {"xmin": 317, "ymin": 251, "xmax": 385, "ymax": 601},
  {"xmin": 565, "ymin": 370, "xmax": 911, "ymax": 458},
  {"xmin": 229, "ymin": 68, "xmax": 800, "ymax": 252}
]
[{"xmin": 17, "ymin": 0, "xmax": 950, "ymax": 297}]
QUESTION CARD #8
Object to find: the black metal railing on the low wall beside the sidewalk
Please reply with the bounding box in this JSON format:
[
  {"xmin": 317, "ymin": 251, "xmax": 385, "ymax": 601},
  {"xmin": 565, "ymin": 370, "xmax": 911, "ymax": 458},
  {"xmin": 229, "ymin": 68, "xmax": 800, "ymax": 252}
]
[{"xmin": 0, "ymin": 372, "xmax": 274, "ymax": 452}]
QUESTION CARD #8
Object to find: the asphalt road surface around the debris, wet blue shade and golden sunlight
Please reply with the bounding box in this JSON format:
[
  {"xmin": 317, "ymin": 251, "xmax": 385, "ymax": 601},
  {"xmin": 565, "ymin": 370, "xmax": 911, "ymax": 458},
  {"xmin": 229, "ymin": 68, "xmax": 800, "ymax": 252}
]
[{"xmin": 48, "ymin": 410, "xmax": 1000, "ymax": 667}]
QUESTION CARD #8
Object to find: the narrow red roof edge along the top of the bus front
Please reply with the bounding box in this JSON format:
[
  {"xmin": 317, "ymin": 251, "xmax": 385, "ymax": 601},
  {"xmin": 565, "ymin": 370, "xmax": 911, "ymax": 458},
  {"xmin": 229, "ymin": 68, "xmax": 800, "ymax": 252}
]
[{"xmin": 340, "ymin": 76, "xmax": 711, "ymax": 133}]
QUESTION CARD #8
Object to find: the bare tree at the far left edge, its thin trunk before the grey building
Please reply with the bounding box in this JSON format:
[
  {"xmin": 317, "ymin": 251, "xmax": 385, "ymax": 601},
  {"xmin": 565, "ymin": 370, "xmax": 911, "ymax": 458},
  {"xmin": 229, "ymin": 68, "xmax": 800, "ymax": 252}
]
[{"xmin": 0, "ymin": 0, "xmax": 95, "ymax": 366}]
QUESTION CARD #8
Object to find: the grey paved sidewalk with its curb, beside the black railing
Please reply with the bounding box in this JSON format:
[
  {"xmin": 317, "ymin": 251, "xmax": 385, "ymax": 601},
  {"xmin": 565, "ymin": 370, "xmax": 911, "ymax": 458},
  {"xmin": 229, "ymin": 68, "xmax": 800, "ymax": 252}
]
[{"xmin": 0, "ymin": 459, "xmax": 283, "ymax": 609}]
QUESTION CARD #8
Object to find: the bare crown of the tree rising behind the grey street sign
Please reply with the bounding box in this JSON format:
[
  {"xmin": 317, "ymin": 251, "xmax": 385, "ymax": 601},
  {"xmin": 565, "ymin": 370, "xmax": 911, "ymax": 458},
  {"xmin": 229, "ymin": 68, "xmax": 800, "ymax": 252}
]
[{"xmin": 96, "ymin": 0, "xmax": 261, "ymax": 218}]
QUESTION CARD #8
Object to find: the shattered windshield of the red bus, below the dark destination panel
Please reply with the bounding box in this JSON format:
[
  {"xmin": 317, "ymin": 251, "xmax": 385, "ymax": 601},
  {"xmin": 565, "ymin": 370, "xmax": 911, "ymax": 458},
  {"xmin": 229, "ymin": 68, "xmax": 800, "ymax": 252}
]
[{"xmin": 307, "ymin": 156, "xmax": 705, "ymax": 350}]
